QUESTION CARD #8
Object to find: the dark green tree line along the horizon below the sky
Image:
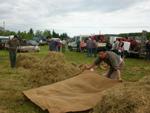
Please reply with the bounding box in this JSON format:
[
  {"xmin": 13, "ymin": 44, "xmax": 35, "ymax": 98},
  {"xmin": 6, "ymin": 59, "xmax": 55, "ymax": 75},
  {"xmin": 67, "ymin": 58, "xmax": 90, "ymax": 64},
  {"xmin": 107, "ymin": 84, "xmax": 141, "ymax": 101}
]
[{"xmin": 0, "ymin": 28, "xmax": 150, "ymax": 40}]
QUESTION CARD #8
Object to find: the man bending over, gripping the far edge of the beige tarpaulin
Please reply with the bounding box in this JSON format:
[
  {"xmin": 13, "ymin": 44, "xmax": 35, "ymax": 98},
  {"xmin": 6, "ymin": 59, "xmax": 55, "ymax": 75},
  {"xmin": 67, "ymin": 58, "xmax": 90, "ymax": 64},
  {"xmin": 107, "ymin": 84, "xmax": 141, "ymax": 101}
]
[{"xmin": 87, "ymin": 49, "xmax": 123, "ymax": 82}]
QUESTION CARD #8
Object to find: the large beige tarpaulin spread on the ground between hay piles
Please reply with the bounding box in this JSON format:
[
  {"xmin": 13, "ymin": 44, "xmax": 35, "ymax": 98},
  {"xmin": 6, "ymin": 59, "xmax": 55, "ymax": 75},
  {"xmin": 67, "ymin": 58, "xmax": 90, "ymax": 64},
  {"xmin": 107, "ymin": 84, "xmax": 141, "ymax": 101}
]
[{"xmin": 23, "ymin": 71, "xmax": 118, "ymax": 113}]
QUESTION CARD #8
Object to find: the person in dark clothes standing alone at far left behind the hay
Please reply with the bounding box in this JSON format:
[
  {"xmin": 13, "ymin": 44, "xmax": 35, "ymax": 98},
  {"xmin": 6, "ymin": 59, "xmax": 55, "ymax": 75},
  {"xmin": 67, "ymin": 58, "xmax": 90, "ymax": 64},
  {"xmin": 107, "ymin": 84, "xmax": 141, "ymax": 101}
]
[{"xmin": 8, "ymin": 35, "xmax": 19, "ymax": 68}]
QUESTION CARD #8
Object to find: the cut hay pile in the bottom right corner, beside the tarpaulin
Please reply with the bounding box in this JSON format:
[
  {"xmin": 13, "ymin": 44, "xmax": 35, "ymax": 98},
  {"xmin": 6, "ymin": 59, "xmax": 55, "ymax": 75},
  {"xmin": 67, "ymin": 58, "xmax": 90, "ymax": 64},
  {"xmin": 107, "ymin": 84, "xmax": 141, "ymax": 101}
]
[{"xmin": 93, "ymin": 76, "xmax": 150, "ymax": 113}]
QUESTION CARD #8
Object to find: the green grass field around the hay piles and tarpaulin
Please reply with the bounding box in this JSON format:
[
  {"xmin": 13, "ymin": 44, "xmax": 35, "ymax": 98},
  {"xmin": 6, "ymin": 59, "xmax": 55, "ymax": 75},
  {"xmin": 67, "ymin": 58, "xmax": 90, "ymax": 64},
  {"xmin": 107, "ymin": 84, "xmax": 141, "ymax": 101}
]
[{"xmin": 0, "ymin": 46, "xmax": 150, "ymax": 113}]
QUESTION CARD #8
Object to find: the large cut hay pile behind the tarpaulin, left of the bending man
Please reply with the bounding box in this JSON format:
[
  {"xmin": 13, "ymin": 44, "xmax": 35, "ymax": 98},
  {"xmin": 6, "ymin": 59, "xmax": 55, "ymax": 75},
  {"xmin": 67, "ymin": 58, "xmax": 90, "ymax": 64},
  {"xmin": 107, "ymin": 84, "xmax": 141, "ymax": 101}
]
[{"xmin": 17, "ymin": 52, "xmax": 80, "ymax": 87}]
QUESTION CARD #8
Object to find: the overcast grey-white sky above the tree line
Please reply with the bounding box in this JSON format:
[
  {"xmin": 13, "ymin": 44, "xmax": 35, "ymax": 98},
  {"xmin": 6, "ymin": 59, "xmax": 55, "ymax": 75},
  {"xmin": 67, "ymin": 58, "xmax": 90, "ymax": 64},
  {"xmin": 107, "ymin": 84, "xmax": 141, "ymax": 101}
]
[{"xmin": 0, "ymin": 0, "xmax": 150, "ymax": 36}]
